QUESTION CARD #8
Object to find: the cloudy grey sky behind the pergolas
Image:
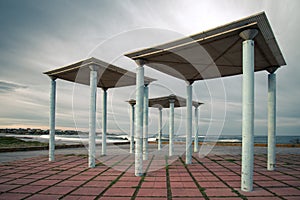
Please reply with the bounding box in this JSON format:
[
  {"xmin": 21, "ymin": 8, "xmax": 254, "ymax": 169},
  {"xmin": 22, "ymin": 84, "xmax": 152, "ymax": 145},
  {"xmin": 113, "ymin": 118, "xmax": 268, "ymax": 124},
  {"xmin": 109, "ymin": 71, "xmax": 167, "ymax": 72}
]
[{"xmin": 0, "ymin": 0, "xmax": 300, "ymax": 135}]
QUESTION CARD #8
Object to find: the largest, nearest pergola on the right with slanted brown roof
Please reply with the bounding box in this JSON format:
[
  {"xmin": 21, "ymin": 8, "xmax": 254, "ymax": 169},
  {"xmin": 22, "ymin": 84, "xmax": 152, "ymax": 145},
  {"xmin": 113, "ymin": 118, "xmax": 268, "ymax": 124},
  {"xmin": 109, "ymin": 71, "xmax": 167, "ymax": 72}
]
[{"xmin": 126, "ymin": 12, "xmax": 286, "ymax": 191}]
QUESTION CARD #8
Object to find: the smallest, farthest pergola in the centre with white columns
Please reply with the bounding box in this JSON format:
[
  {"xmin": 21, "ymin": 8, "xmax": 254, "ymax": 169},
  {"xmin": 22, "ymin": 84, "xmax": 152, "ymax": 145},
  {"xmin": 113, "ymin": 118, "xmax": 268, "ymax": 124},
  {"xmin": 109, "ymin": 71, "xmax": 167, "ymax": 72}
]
[{"xmin": 128, "ymin": 94, "xmax": 203, "ymax": 160}]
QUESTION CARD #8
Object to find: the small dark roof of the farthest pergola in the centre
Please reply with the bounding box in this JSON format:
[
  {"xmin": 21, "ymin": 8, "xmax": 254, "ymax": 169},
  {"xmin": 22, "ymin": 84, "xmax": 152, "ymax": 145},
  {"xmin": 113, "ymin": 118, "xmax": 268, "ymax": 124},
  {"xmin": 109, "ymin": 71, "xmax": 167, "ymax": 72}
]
[{"xmin": 128, "ymin": 95, "xmax": 203, "ymax": 108}]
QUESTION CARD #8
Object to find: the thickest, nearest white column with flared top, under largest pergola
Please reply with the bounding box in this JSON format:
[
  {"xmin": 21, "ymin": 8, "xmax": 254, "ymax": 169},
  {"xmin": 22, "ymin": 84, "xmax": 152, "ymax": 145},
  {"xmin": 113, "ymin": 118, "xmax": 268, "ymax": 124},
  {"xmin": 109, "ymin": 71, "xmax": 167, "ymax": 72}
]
[{"xmin": 240, "ymin": 29, "xmax": 257, "ymax": 192}]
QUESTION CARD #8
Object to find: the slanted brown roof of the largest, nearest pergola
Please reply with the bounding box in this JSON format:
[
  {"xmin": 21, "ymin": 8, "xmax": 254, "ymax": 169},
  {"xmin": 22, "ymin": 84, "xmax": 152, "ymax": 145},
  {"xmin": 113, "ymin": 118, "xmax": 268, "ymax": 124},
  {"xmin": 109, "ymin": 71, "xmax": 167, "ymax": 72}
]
[{"xmin": 126, "ymin": 12, "xmax": 286, "ymax": 81}]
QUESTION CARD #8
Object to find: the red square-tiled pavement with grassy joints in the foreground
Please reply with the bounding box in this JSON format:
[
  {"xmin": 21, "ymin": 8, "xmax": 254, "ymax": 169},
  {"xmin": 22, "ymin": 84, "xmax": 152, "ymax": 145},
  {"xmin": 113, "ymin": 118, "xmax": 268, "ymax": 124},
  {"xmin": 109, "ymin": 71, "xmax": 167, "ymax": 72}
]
[{"xmin": 0, "ymin": 154, "xmax": 300, "ymax": 200}]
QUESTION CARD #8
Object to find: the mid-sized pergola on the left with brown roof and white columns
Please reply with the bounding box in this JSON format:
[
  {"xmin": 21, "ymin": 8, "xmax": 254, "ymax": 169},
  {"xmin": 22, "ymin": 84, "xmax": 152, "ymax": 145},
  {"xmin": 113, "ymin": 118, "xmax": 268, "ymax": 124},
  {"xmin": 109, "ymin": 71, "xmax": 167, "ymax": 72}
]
[{"xmin": 44, "ymin": 57, "xmax": 155, "ymax": 167}]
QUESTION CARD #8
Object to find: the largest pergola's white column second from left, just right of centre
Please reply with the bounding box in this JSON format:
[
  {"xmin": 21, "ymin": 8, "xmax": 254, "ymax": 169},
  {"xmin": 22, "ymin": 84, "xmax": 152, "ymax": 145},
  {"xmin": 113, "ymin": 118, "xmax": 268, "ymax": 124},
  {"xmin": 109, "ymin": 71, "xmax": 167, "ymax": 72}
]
[{"xmin": 185, "ymin": 82, "xmax": 193, "ymax": 164}]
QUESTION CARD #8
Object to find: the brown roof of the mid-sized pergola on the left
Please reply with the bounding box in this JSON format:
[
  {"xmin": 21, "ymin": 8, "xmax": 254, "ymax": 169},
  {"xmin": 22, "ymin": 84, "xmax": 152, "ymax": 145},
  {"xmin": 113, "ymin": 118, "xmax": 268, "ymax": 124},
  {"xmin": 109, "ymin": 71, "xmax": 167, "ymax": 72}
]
[{"xmin": 44, "ymin": 57, "xmax": 155, "ymax": 89}]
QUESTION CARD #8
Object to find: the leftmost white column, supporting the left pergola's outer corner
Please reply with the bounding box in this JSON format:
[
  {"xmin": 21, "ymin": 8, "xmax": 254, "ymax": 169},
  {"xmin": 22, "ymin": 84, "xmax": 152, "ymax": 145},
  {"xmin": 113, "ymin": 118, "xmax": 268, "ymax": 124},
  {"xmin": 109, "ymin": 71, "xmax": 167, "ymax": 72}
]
[{"xmin": 49, "ymin": 76, "xmax": 56, "ymax": 161}]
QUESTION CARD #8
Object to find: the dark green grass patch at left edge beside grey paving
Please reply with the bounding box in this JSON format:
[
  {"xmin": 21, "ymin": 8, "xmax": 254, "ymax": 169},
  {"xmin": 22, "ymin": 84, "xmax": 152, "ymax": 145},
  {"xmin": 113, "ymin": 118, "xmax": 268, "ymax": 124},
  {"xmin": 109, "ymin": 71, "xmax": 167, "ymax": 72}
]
[{"xmin": 0, "ymin": 136, "xmax": 48, "ymax": 148}]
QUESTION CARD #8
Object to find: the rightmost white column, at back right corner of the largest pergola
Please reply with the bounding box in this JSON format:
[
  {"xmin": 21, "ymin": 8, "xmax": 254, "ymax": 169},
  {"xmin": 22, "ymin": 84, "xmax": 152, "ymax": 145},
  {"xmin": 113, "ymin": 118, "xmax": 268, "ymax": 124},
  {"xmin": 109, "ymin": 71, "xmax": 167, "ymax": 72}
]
[{"xmin": 268, "ymin": 73, "xmax": 276, "ymax": 171}]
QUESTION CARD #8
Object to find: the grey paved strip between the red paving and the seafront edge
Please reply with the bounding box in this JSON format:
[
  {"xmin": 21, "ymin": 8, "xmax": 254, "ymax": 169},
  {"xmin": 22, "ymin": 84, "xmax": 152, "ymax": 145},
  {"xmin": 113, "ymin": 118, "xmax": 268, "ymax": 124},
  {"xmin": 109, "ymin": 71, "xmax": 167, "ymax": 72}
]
[{"xmin": 0, "ymin": 144, "xmax": 300, "ymax": 163}]
